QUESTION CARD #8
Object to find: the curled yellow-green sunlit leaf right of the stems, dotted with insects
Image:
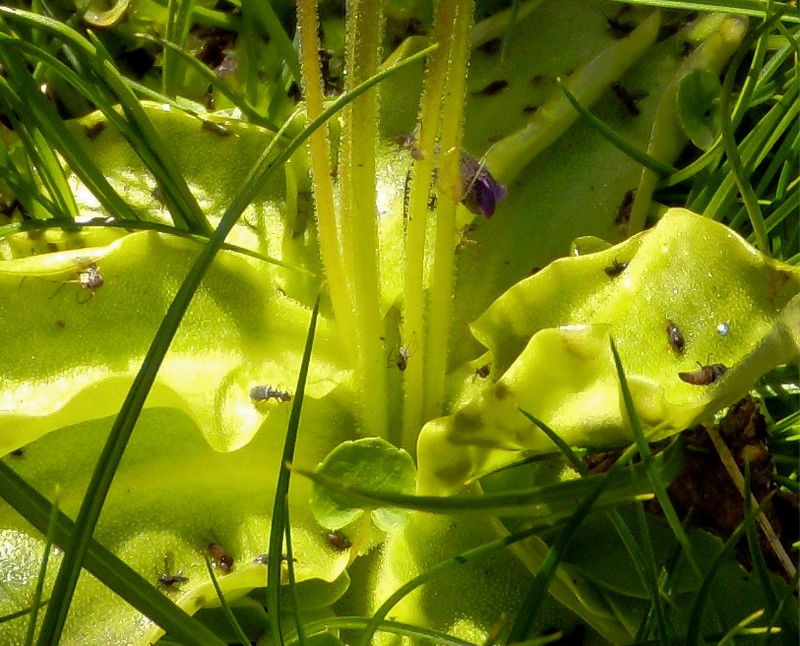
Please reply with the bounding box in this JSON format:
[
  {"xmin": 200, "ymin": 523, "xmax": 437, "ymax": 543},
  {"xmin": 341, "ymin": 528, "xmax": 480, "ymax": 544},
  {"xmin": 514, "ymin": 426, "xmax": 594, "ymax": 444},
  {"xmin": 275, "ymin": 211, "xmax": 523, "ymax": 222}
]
[{"xmin": 418, "ymin": 209, "xmax": 800, "ymax": 493}]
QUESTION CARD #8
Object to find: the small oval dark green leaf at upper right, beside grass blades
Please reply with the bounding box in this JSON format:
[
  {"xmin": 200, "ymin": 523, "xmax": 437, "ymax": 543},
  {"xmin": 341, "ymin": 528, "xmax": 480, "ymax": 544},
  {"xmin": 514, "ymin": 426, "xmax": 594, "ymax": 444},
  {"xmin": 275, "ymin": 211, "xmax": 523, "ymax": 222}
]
[{"xmin": 677, "ymin": 69, "xmax": 722, "ymax": 150}]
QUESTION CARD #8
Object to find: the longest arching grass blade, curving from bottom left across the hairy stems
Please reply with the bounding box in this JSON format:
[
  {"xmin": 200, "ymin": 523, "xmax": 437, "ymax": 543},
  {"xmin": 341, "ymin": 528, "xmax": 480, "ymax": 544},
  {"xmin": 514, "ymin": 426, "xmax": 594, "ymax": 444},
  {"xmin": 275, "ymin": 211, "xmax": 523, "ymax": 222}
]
[{"xmin": 32, "ymin": 43, "xmax": 433, "ymax": 645}]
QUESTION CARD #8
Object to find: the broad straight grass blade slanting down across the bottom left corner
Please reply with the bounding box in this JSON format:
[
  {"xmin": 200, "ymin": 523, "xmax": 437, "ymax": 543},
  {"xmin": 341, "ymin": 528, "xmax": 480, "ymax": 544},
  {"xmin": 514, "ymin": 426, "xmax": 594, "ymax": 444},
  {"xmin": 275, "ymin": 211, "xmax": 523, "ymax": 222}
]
[{"xmin": 0, "ymin": 462, "xmax": 223, "ymax": 646}]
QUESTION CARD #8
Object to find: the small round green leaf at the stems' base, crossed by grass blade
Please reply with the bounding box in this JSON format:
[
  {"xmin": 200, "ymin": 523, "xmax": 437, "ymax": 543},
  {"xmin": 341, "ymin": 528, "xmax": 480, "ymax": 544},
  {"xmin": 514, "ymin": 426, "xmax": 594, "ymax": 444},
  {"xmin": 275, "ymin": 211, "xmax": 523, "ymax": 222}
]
[{"xmin": 311, "ymin": 437, "xmax": 416, "ymax": 533}]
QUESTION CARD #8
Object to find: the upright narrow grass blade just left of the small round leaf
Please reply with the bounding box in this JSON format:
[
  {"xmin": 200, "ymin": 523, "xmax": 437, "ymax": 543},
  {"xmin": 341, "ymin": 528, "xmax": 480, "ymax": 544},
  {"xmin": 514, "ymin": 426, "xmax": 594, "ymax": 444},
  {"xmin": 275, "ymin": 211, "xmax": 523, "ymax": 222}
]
[{"xmin": 267, "ymin": 297, "xmax": 319, "ymax": 644}]
